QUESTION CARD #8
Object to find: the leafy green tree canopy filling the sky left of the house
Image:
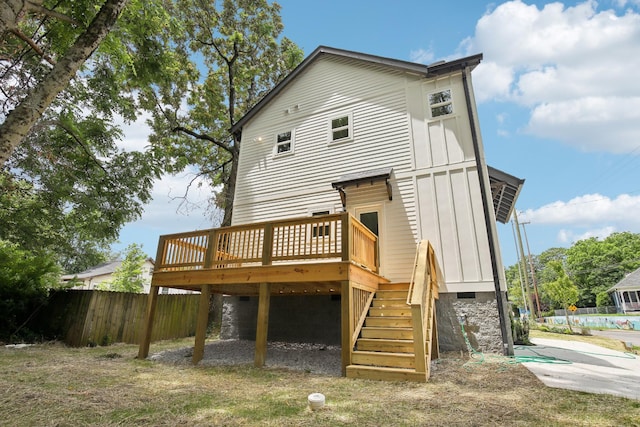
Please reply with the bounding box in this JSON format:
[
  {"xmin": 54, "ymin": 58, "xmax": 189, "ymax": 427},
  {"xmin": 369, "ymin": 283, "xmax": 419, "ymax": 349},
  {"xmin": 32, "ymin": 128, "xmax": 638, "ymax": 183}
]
[{"xmin": 0, "ymin": 0, "xmax": 302, "ymax": 272}]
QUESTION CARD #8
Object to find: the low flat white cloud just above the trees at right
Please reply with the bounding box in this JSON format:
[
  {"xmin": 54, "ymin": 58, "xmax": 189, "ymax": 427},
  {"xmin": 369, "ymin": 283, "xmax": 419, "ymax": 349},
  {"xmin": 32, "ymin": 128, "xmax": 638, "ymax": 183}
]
[{"xmin": 519, "ymin": 194, "xmax": 640, "ymax": 231}]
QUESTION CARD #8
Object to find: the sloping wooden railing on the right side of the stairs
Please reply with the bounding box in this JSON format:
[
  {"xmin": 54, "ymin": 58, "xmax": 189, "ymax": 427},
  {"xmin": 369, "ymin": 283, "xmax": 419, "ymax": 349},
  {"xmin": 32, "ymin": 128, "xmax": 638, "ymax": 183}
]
[{"xmin": 407, "ymin": 240, "xmax": 442, "ymax": 379}]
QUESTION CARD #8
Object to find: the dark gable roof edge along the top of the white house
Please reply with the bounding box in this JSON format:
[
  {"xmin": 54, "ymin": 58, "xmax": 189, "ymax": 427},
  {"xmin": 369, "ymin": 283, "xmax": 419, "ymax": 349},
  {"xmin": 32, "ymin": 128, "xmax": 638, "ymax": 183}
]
[{"xmin": 231, "ymin": 46, "xmax": 482, "ymax": 134}]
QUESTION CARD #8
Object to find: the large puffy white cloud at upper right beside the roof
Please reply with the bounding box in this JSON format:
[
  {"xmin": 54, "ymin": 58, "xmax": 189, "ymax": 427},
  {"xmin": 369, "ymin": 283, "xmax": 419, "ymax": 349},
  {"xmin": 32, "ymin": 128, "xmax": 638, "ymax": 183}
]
[{"xmin": 460, "ymin": 0, "xmax": 640, "ymax": 152}]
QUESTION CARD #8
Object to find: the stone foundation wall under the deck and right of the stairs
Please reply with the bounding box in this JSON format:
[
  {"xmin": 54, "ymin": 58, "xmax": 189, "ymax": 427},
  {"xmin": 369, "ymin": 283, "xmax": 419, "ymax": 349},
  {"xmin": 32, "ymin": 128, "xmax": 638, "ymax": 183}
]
[{"xmin": 220, "ymin": 292, "xmax": 503, "ymax": 354}]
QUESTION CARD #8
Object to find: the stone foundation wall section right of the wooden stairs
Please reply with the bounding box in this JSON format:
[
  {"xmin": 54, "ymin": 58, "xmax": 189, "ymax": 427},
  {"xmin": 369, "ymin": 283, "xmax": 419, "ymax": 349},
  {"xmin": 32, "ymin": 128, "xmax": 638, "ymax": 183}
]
[{"xmin": 436, "ymin": 292, "xmax": 503, "ymax": 354}]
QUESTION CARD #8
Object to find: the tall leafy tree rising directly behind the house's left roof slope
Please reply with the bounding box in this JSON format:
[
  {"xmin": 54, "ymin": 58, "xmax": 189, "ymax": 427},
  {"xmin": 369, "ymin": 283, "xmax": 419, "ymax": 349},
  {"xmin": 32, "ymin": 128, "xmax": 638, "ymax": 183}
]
[{"xmin": 140, "ymin": 0, "xmax": 303, "ymax": 225}]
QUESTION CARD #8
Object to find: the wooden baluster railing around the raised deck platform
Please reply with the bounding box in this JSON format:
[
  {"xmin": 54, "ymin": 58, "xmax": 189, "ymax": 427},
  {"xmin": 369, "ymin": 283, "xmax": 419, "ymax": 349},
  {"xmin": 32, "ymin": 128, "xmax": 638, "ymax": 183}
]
[{"xmin": 155, "ymin": 213, "xmax": 378, "ymax": 272}]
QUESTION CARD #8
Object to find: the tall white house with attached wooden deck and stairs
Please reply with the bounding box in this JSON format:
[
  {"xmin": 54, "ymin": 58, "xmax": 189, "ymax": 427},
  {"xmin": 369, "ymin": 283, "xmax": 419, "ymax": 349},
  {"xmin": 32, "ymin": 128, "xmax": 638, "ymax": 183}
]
[{"xmin": 139, "ymin": 47, "xmax": 524, "ymax": 379}]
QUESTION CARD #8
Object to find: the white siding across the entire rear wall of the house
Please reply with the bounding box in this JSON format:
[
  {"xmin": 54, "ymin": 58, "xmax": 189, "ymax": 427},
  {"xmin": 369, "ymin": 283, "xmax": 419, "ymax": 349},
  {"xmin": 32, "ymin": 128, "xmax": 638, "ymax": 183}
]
[{"xmin": 233, "ymin": 56, "xmax": 500, "ymax": 292}]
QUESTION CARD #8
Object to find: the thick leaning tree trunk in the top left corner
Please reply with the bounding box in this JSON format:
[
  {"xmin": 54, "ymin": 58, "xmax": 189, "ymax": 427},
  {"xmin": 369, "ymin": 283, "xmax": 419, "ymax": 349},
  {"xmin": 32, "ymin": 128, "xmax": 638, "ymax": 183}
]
[{"xmin": 0, "ymin": 0, "xmax": 128, "ymax": 166}]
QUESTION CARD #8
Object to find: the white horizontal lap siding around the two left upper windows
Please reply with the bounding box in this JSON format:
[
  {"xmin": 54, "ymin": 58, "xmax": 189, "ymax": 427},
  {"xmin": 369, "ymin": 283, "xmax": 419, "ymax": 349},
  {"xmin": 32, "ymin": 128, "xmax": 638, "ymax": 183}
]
[{"xmin": 234, "ymin": 56, "xmax": 412, "ymax": 217}]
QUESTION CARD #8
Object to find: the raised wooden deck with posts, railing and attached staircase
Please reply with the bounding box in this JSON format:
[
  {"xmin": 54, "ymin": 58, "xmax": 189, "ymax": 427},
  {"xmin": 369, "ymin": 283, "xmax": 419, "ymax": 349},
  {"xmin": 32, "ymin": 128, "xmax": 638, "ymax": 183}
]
[{"xmin": 138, "ymin": 213, "xmax": 442, "ymax": 382}]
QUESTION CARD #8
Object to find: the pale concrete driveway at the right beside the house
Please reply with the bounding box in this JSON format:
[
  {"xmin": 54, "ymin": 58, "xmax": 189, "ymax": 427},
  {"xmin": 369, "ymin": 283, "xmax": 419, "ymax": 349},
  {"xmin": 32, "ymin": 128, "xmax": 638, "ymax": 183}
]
[{"xmin": 515, "ymin": 338, "xmax": 640, "ymax": 400}]
